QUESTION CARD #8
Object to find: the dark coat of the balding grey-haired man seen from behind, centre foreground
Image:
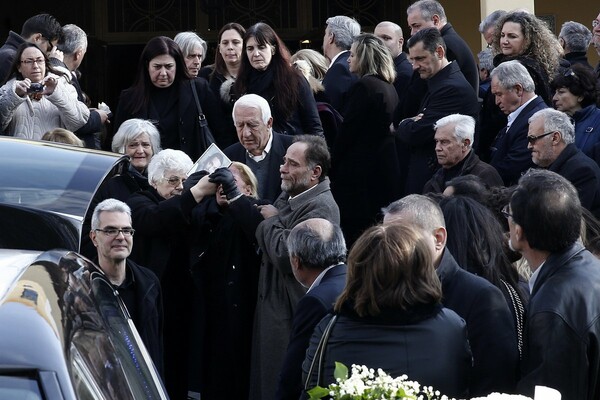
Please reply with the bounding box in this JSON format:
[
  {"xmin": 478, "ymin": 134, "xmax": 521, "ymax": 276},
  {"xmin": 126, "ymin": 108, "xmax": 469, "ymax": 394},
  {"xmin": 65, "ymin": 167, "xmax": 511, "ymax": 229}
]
[{"xmin": 275, "ymin": 264, "xmax": 348, "ymax": 400}]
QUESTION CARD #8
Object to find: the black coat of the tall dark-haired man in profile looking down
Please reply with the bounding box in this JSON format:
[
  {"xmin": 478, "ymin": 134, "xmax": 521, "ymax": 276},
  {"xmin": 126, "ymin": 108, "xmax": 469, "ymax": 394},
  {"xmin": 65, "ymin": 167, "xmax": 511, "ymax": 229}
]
[{"xmin": 396, "ymin": 62, "xmax": 479, "ymax": 194}]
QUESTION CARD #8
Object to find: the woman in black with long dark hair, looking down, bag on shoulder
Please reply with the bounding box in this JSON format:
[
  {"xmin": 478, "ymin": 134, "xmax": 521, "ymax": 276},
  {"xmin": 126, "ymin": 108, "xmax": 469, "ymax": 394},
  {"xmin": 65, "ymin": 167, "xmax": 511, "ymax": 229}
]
[{"xmin": 115, "ymin": 36, "xmax": 231, "ymax": 161}]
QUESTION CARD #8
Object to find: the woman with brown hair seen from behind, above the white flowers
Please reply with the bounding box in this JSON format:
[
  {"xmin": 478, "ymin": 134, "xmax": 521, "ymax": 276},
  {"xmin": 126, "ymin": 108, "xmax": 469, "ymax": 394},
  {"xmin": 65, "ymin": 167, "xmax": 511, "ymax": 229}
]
[{"xmin": 302, "ymin": 222, "xmax": 471, "ymax": 398}]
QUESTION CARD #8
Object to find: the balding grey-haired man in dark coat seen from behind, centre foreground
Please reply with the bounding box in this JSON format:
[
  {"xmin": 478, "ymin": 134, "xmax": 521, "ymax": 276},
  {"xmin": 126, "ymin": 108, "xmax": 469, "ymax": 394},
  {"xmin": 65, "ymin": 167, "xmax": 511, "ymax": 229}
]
[{"xmin": 275, "ymin": 218, "xmax": 347, "ymax": 400}]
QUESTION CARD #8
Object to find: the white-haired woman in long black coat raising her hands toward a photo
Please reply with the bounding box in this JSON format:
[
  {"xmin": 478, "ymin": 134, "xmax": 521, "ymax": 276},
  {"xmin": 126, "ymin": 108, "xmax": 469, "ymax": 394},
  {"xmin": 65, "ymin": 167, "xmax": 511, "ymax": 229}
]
[{"xmin": 127, "ymin": 149, "xmax": 217, "ymax": 399}]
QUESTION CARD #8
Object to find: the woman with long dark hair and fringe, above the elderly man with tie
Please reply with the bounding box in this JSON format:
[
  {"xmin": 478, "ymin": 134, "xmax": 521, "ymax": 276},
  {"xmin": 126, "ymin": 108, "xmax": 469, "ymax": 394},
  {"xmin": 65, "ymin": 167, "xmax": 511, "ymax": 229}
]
[{"xmin": 232, "ymin": 22, "xmax": 323, "ymax": 136}]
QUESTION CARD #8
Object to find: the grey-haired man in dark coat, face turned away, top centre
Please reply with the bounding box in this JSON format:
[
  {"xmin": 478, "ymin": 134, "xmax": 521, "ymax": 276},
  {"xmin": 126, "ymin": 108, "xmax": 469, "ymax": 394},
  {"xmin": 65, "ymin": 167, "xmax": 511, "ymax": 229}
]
[{"xmin": 323, "ymin": 15, "xmax": 360, "ymax": 114}]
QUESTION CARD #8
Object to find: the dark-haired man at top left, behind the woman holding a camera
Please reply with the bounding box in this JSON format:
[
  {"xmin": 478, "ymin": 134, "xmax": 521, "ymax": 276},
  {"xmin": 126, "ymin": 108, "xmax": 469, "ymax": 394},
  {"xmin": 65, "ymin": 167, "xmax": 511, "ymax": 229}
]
[{"xmin": 0, "ymin": 14, "xmax": 61, "ymax": 81}]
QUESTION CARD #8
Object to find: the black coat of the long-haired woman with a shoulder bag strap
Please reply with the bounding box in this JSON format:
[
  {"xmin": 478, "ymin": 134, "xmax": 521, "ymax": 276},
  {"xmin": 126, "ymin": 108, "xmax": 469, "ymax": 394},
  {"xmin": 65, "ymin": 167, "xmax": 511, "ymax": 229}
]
[{"xmin": 115, "ymin": 78, "xmax": 231, "ymax": 161}]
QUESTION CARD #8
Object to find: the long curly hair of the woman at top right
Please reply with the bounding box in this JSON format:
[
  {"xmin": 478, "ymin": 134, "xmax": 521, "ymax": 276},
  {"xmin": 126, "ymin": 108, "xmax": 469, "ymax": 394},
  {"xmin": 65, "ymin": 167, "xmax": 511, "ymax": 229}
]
[{"xmin": 492, "ymin": 11, "xmax": 562, "ymax": 76}]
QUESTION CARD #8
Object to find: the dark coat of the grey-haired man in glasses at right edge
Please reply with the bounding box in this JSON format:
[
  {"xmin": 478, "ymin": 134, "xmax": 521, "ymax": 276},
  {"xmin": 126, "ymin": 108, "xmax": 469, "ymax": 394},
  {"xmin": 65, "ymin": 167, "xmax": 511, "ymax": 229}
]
[{"xmin": 548, "ymin": 143, "xmax": 600, "ymax": 217}]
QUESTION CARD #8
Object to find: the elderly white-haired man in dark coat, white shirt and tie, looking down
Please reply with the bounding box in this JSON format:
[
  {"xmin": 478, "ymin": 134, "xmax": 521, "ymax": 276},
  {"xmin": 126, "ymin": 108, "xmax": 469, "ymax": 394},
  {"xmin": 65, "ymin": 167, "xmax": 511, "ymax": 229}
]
[{"xmin": 224, "ymin": 94, "xmax": 293, "ymax": 203}]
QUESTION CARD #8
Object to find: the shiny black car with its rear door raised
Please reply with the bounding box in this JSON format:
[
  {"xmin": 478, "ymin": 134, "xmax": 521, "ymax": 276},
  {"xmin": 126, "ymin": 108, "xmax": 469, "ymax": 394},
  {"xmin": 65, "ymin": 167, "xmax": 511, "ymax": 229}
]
[{"xmin": 0, "ymin": 137, "xmax": 167, "ymax": 400}]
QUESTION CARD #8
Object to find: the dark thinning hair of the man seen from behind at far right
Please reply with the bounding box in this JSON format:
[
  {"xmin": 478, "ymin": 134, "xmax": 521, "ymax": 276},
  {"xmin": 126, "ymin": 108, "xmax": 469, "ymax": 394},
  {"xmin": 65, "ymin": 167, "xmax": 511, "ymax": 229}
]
[{"xmin": 510, "ymin": 169, "xmax": 581, "ymax": 253}]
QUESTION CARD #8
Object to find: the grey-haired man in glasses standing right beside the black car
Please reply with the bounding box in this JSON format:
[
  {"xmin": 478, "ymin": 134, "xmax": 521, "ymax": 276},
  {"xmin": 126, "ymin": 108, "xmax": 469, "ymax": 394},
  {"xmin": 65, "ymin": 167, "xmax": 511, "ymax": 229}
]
[{"xmin": 90, "ymin": 199, "xmax": 163, "ymax": 374}]
